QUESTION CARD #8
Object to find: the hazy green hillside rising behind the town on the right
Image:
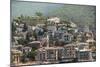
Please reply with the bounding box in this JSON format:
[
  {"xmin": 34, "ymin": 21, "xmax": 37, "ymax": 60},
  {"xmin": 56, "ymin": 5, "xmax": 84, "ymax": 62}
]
[{"xmin": 48, "ymin": 5, "xmax": 96, "ymax": 26}]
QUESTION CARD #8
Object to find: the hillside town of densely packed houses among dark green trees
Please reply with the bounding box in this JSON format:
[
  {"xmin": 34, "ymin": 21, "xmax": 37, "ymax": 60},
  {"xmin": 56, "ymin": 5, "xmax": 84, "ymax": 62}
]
[{"xmin": 11, "ymin": 16, "xmax": 96, "ymax": 66}]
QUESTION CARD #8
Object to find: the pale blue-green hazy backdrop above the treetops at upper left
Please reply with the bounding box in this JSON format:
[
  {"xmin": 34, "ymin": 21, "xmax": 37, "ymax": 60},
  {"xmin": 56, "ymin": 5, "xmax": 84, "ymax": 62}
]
[{"xmin": 11, "ymin": 0, "xmax": 62, "ymax": 17}]
